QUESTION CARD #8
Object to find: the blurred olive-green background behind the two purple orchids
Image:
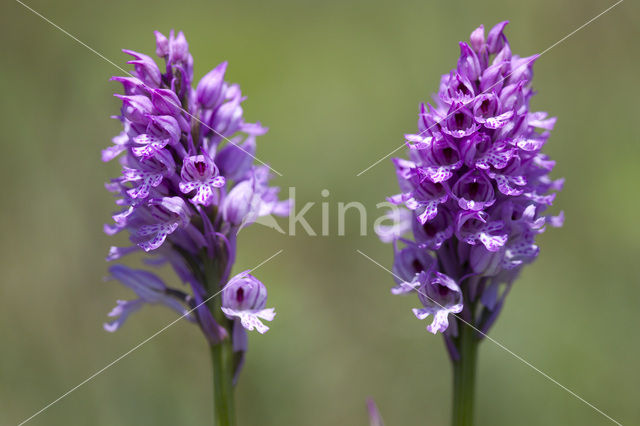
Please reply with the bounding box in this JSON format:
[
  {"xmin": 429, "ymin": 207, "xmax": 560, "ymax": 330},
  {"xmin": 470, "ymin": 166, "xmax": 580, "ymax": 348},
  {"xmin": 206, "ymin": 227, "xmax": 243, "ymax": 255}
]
[{"xmin": 0, "ymin": 0, "xmax": 640, "ymax": 426}]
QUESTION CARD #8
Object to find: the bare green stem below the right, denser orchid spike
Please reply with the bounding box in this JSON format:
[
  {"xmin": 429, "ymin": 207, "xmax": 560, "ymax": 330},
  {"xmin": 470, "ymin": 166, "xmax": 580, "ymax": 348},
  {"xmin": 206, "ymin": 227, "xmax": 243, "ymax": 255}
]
[{"xmin": 451, "ymin": 324, "xmax": 479, "ymax": 426}]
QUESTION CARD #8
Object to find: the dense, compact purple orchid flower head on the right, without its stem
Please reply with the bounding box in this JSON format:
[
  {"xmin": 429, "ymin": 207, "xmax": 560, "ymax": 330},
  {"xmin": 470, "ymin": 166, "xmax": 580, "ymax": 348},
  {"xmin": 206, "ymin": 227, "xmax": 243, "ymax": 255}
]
[{"xmin": 377, "ymin": 22, "xmax": 563, "ymax": 336}]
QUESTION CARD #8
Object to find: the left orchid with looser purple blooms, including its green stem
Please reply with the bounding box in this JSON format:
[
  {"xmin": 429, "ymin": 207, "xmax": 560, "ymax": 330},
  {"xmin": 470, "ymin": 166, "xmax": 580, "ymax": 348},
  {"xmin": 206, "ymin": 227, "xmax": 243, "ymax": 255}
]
[{"xmin": 102, "ymin": 31, "xmax": 290, "ymax": 424}]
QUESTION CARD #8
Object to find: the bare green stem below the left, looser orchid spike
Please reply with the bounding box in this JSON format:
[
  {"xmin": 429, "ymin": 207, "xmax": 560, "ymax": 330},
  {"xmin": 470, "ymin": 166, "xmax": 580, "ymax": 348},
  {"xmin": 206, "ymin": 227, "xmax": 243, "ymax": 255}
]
[{"xmin": 211, "ymin": 339, "xmax": 236, "ymax": 426}]
